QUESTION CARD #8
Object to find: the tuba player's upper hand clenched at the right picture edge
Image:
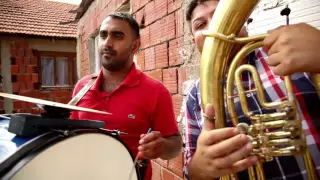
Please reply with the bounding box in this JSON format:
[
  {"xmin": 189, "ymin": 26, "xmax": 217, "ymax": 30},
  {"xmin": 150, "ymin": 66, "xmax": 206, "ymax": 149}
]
[{"xmin": 263, "ymin": 23, "xmax": 320, "ymax": 76}]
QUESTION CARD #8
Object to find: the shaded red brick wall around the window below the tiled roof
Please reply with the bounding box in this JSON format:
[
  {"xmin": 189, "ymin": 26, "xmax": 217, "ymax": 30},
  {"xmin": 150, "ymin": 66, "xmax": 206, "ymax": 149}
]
[{"xmin": 8, "ymin": 41, "xmax": 72, "ymax": 114}]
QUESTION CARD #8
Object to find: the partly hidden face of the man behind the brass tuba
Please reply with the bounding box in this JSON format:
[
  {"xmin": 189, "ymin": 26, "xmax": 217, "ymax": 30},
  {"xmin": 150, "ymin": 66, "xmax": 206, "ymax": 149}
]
[{"xmin": 190, "ymin": 0, "xmax": 247, "ymax": 52}]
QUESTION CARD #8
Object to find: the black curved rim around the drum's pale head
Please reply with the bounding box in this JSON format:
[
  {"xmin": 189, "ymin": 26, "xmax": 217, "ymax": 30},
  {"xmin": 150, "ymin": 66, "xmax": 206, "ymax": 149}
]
[{"xmin": 0, "ymin": 129, "xmax": 141, "ymax": 180}]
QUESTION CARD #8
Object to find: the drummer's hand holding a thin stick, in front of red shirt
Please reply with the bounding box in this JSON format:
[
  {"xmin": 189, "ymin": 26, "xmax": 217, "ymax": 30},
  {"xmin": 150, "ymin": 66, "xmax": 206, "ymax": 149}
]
[{"xmin": 138, "ymin": 131, "xmax": 165, "ymax": 159}]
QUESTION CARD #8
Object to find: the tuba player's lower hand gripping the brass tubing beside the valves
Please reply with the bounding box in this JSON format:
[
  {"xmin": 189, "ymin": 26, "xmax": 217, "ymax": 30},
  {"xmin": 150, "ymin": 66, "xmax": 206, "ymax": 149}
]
[{"xmin": 189, "ymin": 105, "xmax": 257, "ymax": 180}]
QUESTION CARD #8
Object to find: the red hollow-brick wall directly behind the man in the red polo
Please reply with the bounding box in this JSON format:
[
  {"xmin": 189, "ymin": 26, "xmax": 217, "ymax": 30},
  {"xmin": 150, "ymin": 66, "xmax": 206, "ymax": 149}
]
[{"xmin": 77, "ymin": 0, "xmax": 199, "ymax": 180}]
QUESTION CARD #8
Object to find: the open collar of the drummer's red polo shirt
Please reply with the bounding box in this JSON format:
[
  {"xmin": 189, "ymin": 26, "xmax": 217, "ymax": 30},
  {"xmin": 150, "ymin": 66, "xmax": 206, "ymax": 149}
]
[{"xmin": 91, "ymin": 63, "xmax": 141, "ymax": 92}]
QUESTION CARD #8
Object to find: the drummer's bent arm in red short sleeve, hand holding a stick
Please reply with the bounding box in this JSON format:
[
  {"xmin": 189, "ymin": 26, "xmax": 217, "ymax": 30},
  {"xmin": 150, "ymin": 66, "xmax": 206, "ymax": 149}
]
[{"xmin": 138, "ymin": 87, "xmax": 182, "ymax": 160}]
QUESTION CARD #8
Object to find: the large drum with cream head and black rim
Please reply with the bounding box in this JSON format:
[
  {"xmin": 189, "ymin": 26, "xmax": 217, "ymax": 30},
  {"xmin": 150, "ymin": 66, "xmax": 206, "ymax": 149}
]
[{"xmin": 0, "ymin": 119, "xmax": 141, "ymax": 180}]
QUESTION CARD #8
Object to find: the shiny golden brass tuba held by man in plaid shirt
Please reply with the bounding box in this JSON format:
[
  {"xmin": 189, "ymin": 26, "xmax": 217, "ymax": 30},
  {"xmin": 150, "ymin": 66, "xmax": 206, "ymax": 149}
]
[{"xmin": 200, "ymin": 0, "xmax": 320, "ymax": 180}]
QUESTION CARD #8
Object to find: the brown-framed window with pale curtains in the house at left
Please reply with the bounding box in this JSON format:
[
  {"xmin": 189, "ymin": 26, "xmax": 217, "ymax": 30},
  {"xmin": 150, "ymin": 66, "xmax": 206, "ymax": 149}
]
[{"xmin": 38, "ymin": 52, "xmax": 77, "ymax": 87}]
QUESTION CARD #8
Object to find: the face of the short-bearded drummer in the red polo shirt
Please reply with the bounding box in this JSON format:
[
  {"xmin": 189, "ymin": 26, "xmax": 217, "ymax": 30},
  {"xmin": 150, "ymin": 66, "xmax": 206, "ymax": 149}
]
[{"xmin": 99, "ymin": 17, "xmax": 139, "ymax": 72}]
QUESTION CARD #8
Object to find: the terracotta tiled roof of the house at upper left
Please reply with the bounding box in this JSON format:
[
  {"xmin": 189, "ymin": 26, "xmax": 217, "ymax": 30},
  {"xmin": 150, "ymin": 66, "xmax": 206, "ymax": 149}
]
[{"xmin": 0, "ymin": 0, "xmax": 77, "ymax": 38}]
